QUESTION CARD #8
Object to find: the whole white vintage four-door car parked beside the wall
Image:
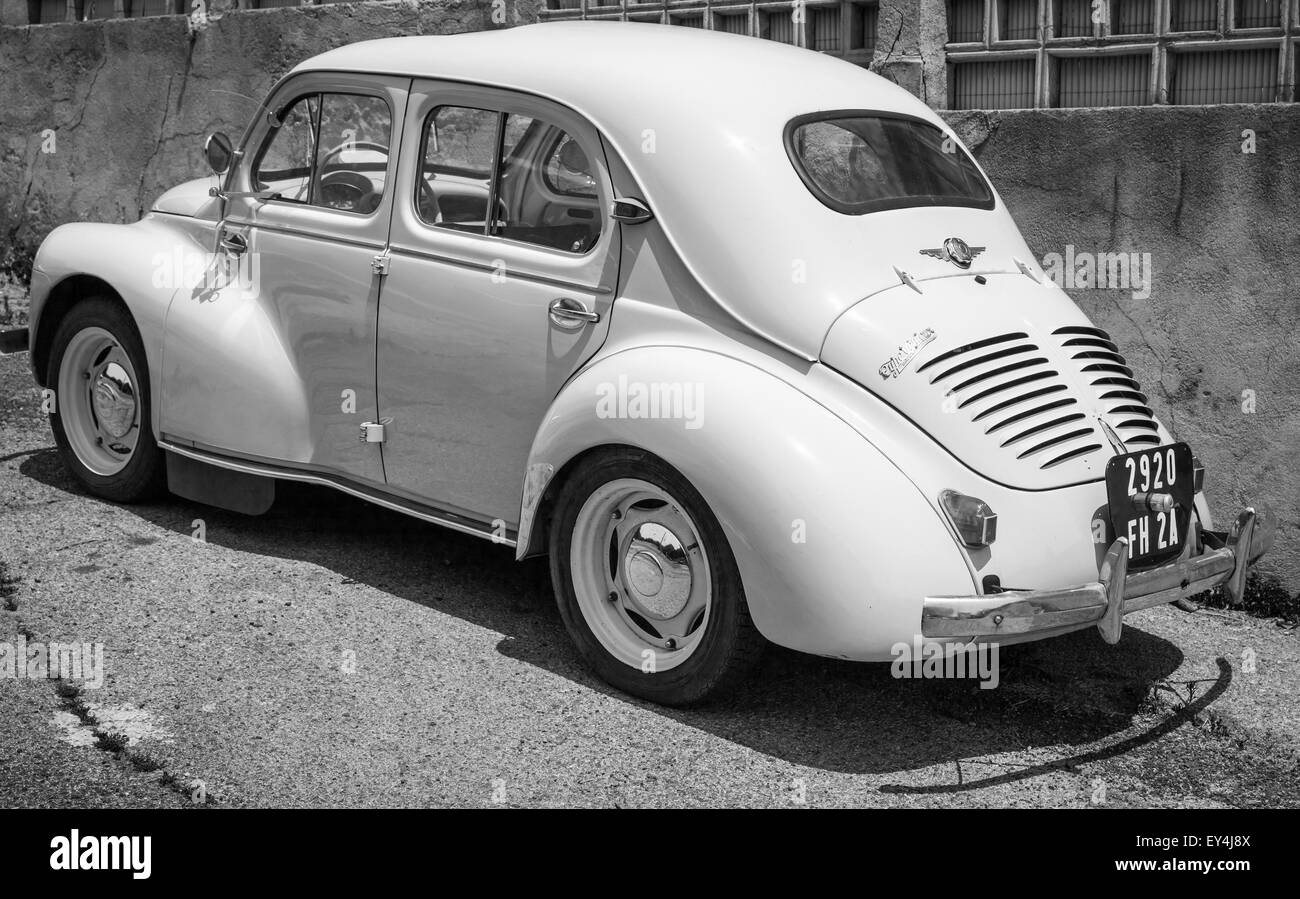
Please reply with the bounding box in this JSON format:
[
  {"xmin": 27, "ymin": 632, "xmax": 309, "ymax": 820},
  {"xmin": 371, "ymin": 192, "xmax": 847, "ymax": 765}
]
[{"xmin": 17, "ymin": 22, "xmax": 1274, "ymax": 704}]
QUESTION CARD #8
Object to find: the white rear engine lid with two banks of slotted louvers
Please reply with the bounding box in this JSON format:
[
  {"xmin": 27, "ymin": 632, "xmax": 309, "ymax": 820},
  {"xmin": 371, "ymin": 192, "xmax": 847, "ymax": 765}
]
[{"xmin": 822, "ymin": 273, "xmax": 1170, "ymax": 490}]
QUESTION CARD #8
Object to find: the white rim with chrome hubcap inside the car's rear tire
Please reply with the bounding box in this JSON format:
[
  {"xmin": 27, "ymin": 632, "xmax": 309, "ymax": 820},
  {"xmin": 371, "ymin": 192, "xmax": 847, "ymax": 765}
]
[{"xmin": 571, "ymin": 478, "xmax": 712, "ymax": 670}]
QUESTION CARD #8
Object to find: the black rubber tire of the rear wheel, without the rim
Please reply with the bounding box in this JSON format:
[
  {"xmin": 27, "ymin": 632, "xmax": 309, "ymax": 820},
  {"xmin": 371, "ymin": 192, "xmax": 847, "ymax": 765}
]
[{"xmin": 550, "ymin": 448, "xmax": 766, "ymax": 705}]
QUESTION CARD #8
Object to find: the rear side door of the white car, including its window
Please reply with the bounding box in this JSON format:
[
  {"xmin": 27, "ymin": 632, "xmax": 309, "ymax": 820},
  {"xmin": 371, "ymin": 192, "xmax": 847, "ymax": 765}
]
[{"xmin": 378, "ymin": 81, "xmax": 619, "ymax": 529}]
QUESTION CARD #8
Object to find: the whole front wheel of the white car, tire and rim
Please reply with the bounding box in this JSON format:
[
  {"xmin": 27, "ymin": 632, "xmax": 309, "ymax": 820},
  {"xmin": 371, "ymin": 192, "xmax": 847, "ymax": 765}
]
[{"xmin": 46, "ymin": 296, "xmax": 165, "ymax": 503}]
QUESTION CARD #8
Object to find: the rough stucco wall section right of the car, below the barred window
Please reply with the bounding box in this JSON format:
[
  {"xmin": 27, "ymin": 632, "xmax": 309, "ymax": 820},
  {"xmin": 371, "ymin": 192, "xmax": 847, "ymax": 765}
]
[{"xmin": 944, "ymin": 104, "xmax": 1300, "ymax": 594}]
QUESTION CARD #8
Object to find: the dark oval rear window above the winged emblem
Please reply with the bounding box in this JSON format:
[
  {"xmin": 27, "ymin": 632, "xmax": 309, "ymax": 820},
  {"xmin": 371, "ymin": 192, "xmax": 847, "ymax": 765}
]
[{"xmin": 785, "ymin": 113, "xmax": 993, "ymax": 216}]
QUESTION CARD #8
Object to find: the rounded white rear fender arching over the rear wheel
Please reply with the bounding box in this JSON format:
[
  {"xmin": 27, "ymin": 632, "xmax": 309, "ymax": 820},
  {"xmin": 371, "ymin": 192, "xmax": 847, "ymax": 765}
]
[{"xmin": 519, "ymin": 347, "xmax": 972, "ymax": 660}]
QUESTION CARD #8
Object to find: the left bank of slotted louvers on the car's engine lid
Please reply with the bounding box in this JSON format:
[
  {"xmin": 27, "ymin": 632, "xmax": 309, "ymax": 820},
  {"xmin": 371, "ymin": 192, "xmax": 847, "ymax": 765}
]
[{"xmin": 917, "ymin": 331, "xmax": 1104, "ymax": 469}]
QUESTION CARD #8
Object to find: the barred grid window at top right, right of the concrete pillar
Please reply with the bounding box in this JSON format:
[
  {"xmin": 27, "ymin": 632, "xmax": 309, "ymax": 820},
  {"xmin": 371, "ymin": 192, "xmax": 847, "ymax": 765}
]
[{"xmin": 946, "ymin": 0, "xmax": 1300, "ymax": 109}]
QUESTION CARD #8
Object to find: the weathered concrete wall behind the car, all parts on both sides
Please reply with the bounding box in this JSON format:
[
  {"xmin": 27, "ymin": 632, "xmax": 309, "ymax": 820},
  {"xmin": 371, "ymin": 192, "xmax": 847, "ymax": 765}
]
[{"xmin": 0, "ymin": 0, "xmax": 1300, "ymax": 592}]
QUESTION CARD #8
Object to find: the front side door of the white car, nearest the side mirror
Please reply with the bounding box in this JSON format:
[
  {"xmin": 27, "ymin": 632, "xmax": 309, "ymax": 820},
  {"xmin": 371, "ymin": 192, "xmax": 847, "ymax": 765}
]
[{"xmin": 163, "ymin": 73, "xmax": 410, "ymax": 483}]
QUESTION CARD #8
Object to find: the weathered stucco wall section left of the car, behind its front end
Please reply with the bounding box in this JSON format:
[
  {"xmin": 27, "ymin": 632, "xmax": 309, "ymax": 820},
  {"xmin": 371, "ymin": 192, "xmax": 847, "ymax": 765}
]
[{"xmin": 0, "ymin": 0, "xmax": 536, "ymax": 244}]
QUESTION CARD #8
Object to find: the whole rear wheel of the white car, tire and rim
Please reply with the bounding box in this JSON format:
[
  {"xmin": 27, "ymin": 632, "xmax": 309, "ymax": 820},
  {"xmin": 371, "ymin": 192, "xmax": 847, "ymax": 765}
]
[{"xmin": 550, "ymin": 450, "xmax": 763, "ymax": 705}]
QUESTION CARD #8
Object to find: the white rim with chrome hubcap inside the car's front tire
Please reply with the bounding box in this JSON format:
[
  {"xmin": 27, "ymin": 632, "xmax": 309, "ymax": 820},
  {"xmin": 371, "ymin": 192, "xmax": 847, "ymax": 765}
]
[{"xmin": 56, "ymin": 327, "xmax": 140, "ymax": 475}]
